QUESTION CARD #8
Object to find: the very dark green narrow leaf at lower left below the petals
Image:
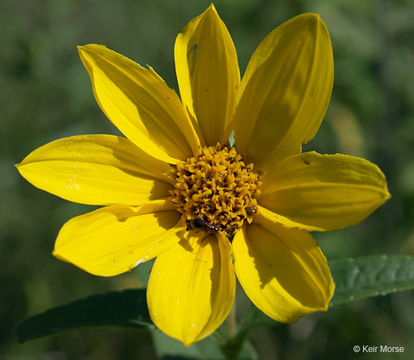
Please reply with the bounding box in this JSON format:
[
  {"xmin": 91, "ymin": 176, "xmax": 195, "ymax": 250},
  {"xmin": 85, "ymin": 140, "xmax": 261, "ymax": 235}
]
[{"xmin": 15, "ymin": 289, "xmax": 152, "ymax": 342}]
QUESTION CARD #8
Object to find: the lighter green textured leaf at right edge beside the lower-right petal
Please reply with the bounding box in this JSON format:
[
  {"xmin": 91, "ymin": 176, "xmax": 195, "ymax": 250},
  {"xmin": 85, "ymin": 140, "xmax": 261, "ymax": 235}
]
[{"xmin": 329, "ymin": 255, "xmax": 414, "ymax": 306}]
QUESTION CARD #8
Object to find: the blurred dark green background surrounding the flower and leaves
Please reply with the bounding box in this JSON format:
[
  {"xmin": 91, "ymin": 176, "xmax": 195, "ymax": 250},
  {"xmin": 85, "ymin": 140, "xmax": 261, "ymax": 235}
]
[{"xmin": 0, "ymin": 0, "xmax": 414, "ymax": 360}]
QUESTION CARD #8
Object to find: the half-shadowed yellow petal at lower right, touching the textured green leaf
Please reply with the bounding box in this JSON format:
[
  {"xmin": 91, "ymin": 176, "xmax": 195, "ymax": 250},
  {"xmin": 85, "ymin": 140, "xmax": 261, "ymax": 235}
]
[{"xmin": 233, "ymin": 223, "xmax": 335, "ymax": 323}]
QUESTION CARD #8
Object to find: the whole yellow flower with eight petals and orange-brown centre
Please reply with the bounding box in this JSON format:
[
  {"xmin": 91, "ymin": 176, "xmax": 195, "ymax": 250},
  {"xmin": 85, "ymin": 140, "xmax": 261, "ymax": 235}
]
[{"xmin": 17, "ymin": 5, "xmax": 390, "ymax": 345}]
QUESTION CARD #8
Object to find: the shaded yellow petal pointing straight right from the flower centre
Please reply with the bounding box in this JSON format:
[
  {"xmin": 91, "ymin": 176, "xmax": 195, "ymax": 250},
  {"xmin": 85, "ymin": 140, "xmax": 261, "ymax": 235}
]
[{"xmin": 258, "ymin": 152, "xmax": 390, "ymax": 231}]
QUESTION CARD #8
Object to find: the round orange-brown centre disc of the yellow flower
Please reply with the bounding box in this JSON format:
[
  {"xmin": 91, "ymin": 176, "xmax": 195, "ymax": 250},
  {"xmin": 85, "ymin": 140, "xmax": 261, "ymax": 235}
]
[{"xmin": 170, "ymin": 143, "xmax": 261, "ymax": 238}]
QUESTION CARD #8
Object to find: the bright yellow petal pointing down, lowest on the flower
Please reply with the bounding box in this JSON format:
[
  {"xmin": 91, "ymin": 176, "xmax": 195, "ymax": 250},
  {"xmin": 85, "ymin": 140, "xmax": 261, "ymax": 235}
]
[{"xmin": 147, "ymin": 232, "xmax": 235, "ymax": 346}]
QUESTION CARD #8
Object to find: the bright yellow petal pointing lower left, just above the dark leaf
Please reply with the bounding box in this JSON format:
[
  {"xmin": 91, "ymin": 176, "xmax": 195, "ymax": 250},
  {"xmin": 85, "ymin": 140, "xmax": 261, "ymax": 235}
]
[{"xmin": 53, "ymin": 201, "xmax": 186, "ymax": 276}]
